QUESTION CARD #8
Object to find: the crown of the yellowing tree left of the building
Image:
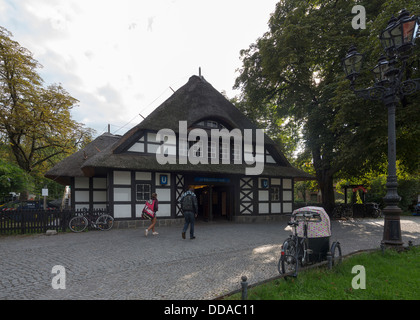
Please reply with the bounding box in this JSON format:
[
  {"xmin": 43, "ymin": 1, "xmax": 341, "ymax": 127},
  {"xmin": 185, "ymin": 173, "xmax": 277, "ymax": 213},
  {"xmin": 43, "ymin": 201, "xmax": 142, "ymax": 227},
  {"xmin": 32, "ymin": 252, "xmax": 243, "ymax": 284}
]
[{"xmin": 0, "ymin": 27, "xmax": 92, "ymax": 172}]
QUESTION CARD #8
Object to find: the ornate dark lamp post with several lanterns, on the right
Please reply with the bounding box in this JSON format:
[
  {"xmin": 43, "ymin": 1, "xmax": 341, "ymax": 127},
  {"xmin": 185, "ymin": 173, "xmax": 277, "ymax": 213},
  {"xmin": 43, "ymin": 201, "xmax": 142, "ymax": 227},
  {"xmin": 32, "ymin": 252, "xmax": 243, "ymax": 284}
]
[{"xmin": 342, "ymin": 9, "xmax": 420, "ymax": 247}]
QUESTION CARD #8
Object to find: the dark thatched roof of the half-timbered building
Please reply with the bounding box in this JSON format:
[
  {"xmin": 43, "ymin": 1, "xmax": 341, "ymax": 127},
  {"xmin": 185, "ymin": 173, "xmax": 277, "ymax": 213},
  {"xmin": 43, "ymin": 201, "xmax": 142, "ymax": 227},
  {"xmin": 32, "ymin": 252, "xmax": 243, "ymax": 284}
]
[{"xmin": 46, "ymin": 76, "xmax": 312, "ymax": 185}]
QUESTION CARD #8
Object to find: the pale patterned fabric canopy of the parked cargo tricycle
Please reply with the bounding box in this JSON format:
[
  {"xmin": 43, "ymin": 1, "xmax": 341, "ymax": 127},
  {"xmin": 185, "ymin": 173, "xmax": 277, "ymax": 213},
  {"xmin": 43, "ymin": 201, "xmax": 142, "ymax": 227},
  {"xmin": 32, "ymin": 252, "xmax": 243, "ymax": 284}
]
[{"xmin": 292, "ymin": 206, "xmax": 331, "ymax": 238}]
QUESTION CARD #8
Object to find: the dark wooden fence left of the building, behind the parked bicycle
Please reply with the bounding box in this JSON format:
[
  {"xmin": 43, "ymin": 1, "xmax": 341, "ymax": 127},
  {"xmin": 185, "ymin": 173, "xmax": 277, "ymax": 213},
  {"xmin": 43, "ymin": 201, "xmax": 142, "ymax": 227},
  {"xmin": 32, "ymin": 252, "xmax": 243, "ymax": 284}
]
[{"xmin": 0, "ymin": 209, "xmax": 109, "ymax": 234}]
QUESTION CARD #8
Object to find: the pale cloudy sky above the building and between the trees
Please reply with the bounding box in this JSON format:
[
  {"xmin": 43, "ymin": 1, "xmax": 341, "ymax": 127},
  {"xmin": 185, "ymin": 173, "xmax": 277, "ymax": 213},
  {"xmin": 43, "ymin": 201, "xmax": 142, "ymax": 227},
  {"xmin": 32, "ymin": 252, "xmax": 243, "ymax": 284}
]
[{"xmin": 0, "ymin": 0, "xmax": 278, "ymax": 136}]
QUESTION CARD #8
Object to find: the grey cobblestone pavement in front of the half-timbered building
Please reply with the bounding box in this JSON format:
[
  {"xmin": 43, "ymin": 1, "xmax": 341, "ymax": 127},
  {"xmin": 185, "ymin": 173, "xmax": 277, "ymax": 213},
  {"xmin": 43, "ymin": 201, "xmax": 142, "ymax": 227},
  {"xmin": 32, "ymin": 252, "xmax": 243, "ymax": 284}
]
[{"xmin": 0, "ymin": 217, "xmax": 420, "ymax": 300}]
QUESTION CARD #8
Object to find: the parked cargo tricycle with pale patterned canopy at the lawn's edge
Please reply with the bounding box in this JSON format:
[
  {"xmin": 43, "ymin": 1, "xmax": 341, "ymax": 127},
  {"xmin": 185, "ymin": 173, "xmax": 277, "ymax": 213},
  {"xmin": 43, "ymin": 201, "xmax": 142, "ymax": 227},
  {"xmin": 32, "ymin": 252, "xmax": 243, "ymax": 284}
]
[{"xmin": 278, "ymin": 206, "xmax": 341, "ymax": 276}]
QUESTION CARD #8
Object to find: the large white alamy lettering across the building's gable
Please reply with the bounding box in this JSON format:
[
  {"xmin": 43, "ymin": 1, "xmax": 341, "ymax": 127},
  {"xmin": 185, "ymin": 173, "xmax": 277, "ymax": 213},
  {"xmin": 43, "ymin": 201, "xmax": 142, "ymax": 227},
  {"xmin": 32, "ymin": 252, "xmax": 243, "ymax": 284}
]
[{"xmin": 156, "ymin": 121, "xmax": 265, "ymax": 175}]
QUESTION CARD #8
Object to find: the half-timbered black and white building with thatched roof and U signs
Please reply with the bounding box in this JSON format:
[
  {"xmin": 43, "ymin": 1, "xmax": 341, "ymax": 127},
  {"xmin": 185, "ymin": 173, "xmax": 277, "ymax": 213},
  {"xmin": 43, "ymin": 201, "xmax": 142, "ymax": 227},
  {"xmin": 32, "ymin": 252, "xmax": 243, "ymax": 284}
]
[{"xmin": 46, "ymin": 76, "xmax": 312, "ymax": 221}]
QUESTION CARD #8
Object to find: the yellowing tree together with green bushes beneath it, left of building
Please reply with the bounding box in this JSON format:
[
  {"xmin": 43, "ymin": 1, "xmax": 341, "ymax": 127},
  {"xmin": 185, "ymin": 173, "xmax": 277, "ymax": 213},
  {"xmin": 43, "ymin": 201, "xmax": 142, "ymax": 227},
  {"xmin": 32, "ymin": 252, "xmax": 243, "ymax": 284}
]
[{"xmin": 0, "ymin": 27, "xmax": 93, "ymax": 199}]
